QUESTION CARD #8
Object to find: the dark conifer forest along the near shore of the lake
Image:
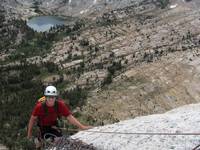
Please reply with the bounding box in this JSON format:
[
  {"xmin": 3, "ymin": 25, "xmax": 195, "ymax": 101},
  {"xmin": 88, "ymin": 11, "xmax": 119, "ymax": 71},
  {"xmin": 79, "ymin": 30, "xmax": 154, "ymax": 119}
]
[{"xmin": 0, "ymin": 15, "xmax": 85, "ymax": 62}]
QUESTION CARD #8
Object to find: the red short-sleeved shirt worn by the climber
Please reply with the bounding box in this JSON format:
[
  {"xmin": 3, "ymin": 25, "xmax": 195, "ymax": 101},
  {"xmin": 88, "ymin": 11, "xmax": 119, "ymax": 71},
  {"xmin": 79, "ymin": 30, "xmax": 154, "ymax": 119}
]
[{"xmin": 32, "ymin": 100, "xmax": 71, "ymax": 126}]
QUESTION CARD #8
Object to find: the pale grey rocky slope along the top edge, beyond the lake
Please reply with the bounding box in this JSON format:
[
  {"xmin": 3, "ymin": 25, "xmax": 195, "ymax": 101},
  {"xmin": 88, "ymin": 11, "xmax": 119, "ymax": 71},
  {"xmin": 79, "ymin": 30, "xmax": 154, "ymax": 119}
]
[{"xmin": 2, "ymin": 0, "xmax": 143, "ymax": 18}]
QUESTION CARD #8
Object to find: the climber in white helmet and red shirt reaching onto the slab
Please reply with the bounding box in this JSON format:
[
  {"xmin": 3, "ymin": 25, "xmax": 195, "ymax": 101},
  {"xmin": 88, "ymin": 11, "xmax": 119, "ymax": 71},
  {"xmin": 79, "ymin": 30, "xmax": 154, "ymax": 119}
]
[{"xmin": 27, "ymin": 86, "xmax": 91, "ymax": 148}]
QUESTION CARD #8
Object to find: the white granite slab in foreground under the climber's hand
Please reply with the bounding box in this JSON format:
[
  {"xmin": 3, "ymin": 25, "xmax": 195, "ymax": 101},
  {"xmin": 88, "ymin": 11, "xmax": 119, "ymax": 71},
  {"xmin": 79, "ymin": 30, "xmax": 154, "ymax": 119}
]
[{"xmin": 72, "ymin": 104, "xmax": 200, "ymax": 150}]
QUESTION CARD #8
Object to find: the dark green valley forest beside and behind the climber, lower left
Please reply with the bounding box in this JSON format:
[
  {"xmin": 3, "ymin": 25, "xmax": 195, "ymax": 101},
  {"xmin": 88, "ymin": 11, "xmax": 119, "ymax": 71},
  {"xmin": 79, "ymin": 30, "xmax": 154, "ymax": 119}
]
[{"xmin": 0, "ymin": 62, "xmax": 87, "ymax": 149}]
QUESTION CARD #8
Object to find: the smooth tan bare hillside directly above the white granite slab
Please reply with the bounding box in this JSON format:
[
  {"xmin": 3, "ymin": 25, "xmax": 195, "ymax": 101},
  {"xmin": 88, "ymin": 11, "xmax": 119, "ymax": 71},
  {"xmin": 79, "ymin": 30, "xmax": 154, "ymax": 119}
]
[{"xmin": 80, "ymin": 52, "xmax": 200, "ymax": 125}]
